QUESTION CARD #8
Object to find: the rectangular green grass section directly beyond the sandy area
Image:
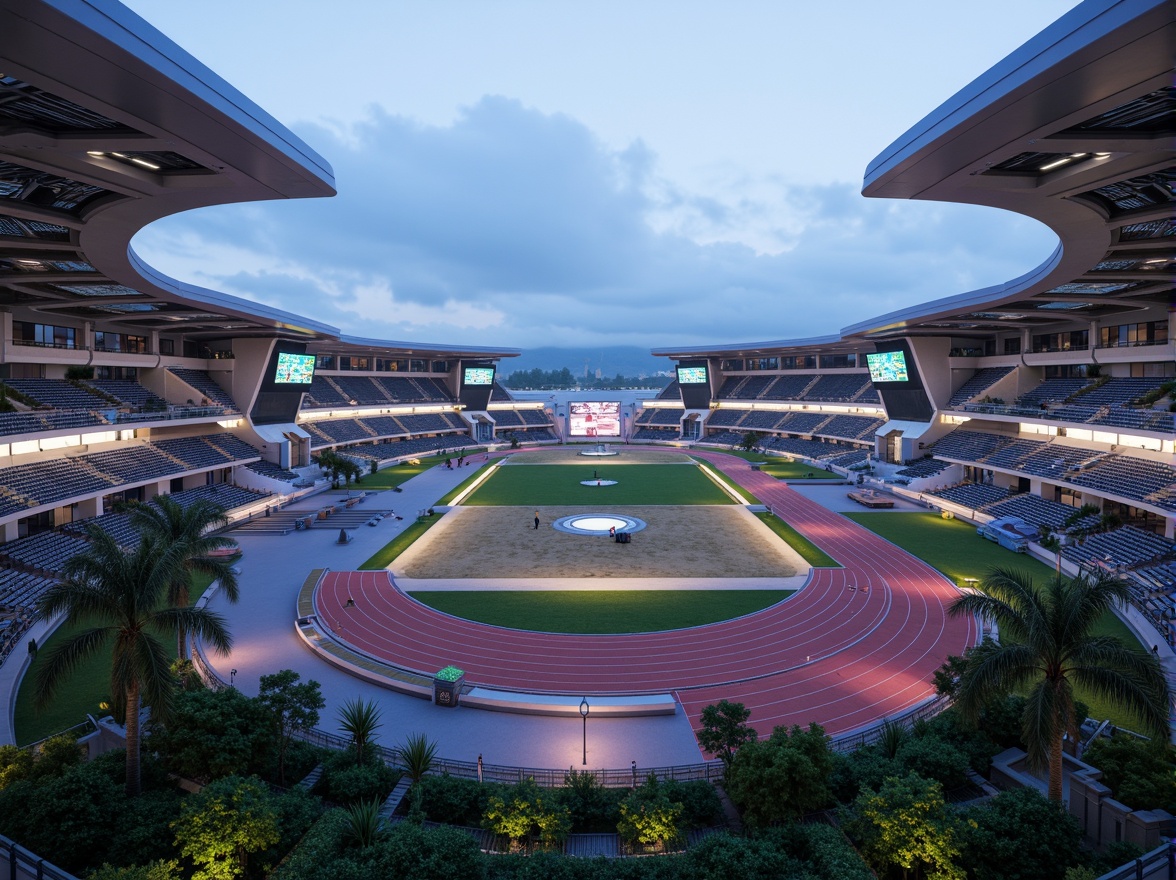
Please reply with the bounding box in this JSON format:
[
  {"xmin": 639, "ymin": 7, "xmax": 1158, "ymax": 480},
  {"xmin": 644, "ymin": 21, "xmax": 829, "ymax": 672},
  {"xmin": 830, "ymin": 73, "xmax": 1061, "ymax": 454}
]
[{"xmin": 465, "ymin": 465, "xmax": 734, "ymax": 507}]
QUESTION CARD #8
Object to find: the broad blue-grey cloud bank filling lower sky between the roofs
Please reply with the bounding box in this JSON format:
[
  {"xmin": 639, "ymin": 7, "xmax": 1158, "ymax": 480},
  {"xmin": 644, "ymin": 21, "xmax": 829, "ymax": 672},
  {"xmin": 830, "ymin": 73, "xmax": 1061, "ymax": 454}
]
[{"xmin": 135, "ymin": 96, "xmax": 1054, "ymax": 348}]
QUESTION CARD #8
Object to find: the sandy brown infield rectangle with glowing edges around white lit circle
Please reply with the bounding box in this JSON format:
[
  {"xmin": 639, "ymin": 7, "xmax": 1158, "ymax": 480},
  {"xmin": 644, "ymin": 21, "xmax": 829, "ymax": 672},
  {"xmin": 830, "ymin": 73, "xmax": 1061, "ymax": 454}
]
[{"xmin": 392, "ymin": 504, "xmax": 809, "ymax": 587}]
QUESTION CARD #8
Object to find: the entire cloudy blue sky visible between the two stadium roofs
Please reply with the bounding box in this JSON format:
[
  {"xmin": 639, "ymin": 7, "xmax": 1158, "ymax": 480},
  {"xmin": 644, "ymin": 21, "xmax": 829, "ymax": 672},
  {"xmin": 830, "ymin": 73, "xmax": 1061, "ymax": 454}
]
[{"xmin": 128, "ymin": 0, "xmax": 1075, "ymax": 348}]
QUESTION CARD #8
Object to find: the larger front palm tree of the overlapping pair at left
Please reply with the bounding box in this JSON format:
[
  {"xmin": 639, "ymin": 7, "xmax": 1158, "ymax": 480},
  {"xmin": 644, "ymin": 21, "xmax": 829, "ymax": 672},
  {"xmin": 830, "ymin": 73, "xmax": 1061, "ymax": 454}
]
[{"xmin": 34, "ymin": 526, "xmax": 232, "ymax": 796}]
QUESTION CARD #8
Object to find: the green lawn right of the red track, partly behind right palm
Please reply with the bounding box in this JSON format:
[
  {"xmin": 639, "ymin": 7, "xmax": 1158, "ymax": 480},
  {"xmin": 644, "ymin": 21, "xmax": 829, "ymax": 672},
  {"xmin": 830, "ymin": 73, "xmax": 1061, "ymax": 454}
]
[{"xmin": 844, "ymin": 513, "xmax": 1145, "ymax": 731}]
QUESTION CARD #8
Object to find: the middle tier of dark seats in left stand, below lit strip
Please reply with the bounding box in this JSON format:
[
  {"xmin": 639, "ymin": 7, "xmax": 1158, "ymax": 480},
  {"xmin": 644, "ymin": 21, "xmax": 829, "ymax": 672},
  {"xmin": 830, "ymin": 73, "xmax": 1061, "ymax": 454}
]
[{"xmin": 0, "ymin": 433, "xmax": 261, "ymax": 516}]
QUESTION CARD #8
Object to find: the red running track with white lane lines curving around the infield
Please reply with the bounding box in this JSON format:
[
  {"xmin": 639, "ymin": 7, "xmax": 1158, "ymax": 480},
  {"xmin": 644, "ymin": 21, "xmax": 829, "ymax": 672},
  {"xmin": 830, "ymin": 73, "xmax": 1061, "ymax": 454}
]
[{"xmin": 315, "ymin": 453, "xmax": 977, "ymax": 735}]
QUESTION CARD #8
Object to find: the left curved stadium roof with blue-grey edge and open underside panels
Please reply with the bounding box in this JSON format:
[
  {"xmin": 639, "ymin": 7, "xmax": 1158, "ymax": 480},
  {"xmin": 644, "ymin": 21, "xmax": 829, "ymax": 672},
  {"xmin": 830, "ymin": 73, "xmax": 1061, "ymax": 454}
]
[{"xmin": 0, "ymin": 0, "xmax": 517, "ymax": 356}]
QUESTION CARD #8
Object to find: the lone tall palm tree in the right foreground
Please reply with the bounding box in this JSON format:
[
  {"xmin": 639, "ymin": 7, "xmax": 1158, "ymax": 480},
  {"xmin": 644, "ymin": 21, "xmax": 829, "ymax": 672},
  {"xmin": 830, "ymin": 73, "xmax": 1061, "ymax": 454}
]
[{"xmin": 951, "ymin": 568, "xmax": 1170, "ymax": 800}]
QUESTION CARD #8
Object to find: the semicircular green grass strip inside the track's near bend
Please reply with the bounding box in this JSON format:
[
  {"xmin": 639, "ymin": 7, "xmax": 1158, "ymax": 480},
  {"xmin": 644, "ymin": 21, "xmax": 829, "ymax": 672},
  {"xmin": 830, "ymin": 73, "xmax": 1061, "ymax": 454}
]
[{"xmin": 412, "ymin": 589, "xmax": 794, "ymax": 634}]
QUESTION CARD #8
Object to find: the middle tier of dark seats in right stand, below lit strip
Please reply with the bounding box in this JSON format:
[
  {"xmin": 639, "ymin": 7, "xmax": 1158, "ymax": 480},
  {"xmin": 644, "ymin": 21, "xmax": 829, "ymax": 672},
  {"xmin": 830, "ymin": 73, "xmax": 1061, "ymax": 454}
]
[{"xmin": 931, "ymin": 428, "xmax": 1176, "ymax": 511}]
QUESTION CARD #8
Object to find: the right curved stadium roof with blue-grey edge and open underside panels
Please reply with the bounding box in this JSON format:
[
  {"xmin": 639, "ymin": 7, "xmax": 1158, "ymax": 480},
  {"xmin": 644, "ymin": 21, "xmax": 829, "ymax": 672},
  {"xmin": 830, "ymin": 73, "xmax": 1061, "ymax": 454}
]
[{"xmin": 654, "ymin": 0, "xmax": 1176, "ymax": 356}]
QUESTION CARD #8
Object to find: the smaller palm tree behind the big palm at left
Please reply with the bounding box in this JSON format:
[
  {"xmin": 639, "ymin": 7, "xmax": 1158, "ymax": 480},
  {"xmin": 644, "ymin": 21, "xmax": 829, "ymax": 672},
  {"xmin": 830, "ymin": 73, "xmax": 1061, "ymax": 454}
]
[{"xmin": 131, "ymin": 495, "xmax": 240, "ymax": 658}]
